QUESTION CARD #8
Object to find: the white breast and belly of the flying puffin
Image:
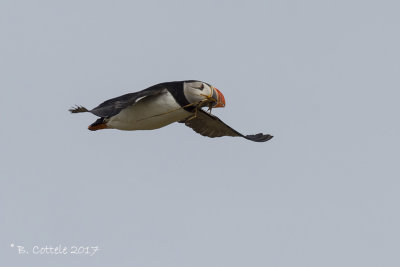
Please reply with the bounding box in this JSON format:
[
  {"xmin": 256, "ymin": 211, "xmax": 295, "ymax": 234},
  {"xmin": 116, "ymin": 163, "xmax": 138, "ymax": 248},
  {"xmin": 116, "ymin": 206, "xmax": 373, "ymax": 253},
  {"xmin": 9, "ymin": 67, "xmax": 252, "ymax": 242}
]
[{"xmin": 107, "ymin": 91, "xmax": 192, "ymax": 130}]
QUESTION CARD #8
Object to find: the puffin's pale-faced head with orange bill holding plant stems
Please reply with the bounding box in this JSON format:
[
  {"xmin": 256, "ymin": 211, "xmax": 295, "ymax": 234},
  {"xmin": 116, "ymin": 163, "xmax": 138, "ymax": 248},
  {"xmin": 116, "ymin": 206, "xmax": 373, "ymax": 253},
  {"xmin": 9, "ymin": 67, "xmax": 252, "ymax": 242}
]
[{"xmin": 183, "ymin": 81, "xmax": 225, "ymax": 108}]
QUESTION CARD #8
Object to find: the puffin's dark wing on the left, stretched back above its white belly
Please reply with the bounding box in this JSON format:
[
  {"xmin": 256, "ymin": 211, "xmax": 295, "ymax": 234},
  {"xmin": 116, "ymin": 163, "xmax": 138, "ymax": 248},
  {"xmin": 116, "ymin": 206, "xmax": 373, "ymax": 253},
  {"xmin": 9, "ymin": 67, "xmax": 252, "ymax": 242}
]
[{"xmin": 70, "ymin": 85, "xmax": 167, "ymax": 118}]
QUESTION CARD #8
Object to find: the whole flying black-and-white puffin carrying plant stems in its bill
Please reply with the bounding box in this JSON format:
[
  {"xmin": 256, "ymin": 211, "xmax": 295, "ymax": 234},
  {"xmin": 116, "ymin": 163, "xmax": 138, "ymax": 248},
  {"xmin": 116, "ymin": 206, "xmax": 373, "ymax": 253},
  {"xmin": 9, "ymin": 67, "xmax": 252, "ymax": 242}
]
[{"xmin": 69, "ymin": 80, "xmax": 272, "ymax": 142}]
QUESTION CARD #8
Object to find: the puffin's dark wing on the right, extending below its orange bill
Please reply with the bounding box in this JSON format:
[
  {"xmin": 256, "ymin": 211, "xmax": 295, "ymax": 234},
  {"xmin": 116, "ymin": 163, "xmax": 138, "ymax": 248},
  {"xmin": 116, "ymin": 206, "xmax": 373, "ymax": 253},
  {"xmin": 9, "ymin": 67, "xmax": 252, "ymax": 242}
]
[{"xmin": 181, "ymin": 109, "xmax": 272, "ymax": 142}]
